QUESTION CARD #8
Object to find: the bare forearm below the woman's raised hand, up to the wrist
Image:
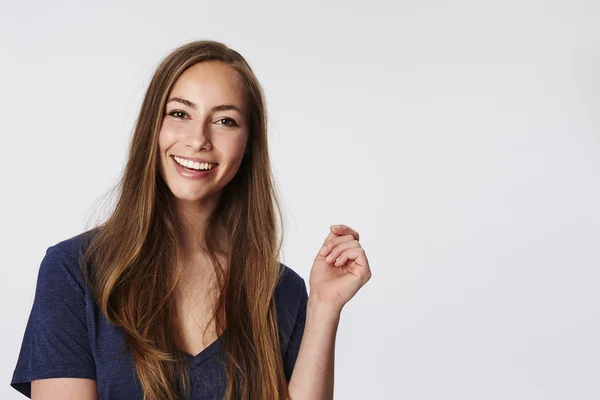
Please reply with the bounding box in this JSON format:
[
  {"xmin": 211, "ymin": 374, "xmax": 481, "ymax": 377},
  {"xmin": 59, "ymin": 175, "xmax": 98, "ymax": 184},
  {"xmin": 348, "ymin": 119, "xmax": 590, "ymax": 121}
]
[{"xmin": 289, "ymin": 296, "xmax": 341, "ymax": 400}]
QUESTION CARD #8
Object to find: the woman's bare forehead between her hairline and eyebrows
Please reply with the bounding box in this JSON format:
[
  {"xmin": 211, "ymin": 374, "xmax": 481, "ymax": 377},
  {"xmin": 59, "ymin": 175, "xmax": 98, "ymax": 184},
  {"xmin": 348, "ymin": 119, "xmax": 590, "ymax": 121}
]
[{"xmin": 169, "ymin": 61, "xmax": 245, "ymax": 107}]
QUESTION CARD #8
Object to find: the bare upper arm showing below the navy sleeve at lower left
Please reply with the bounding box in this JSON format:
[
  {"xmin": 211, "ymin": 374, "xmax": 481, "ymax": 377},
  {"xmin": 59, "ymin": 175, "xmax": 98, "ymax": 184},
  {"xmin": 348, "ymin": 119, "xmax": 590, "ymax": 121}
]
[{"xmin": 31, "ymin": 378, "xmax": 98, "ymax": 400}]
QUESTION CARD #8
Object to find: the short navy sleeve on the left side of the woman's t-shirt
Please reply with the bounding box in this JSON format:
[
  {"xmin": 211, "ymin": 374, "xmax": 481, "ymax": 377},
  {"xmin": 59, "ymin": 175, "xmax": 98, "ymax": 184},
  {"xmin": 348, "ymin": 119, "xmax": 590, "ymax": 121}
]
[{"xmin": 11, "ymin": 245, "xmax": 96, "ymax": 397}]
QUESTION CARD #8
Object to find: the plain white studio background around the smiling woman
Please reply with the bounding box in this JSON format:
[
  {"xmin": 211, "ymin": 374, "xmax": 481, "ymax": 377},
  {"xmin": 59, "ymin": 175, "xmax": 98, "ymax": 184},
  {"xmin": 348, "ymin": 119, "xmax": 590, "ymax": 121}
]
[{"xmin": 0, "ymin": 0, "xmax": 600, "ymax": 400}]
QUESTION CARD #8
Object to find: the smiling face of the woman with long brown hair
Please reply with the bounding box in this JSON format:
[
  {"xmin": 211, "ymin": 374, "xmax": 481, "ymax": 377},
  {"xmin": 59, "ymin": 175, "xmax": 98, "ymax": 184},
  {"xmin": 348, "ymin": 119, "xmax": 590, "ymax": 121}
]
[{"xmin": 158, "ymin": 61, "xmax": 249, "ymax": 204}]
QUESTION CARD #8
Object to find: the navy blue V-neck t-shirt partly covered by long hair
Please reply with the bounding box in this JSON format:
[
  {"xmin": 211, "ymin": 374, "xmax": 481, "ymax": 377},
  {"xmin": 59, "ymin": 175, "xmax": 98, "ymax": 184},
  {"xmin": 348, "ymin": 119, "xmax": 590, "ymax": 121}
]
[{"xmin": 11, "ymin": 234, "xmax": 308, "ymax": 400}]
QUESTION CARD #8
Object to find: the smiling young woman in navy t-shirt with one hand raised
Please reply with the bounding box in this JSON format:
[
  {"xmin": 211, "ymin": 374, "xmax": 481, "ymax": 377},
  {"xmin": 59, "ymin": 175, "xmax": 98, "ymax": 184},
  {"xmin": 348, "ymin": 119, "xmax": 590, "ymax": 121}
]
[{"xmin": 11, "ymin": 41, "xmax": 371, "ymax": 400}]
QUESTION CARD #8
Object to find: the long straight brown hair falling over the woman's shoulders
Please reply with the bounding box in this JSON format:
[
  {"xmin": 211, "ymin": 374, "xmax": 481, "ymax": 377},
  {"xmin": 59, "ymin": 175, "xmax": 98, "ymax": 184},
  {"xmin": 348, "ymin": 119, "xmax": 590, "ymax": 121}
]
[{"xmin": 82, "ymin": 40, "xmax": 288, "ymax": 400}]
